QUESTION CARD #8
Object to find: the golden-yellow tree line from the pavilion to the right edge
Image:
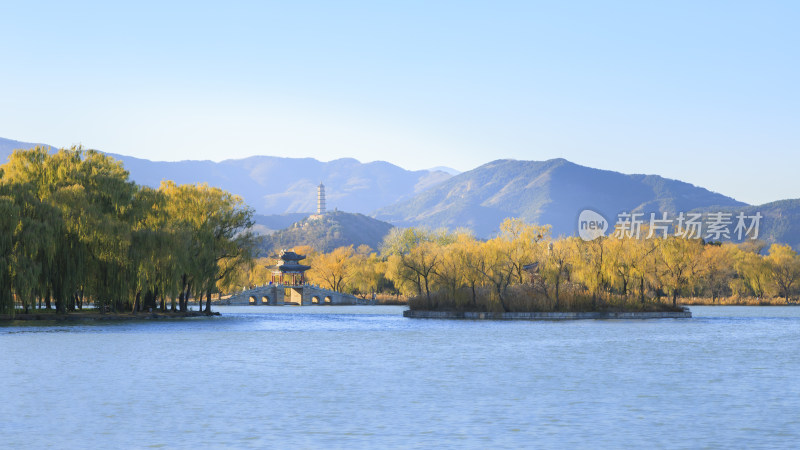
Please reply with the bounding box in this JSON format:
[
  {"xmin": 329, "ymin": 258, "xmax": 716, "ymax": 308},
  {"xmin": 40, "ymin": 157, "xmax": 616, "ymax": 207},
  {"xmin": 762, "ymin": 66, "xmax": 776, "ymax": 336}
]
[{"xmin": 241, "ymin": 219, "xmax": 800, "ymax": 311}]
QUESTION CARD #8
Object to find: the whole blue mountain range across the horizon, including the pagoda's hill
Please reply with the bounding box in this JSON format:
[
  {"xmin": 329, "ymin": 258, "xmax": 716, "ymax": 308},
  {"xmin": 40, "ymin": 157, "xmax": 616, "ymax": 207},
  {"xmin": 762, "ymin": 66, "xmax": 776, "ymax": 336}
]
[{"xmin": 0, "ymin": 138, "xmax": 800, "ymax": 249}]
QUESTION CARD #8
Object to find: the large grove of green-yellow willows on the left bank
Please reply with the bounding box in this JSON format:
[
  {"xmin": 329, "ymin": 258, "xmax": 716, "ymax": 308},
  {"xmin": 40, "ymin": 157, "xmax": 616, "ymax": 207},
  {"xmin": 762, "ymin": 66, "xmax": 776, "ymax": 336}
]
[{"xmin": 0, "ymin": 147, "xmax": 255, "ymax": 313}]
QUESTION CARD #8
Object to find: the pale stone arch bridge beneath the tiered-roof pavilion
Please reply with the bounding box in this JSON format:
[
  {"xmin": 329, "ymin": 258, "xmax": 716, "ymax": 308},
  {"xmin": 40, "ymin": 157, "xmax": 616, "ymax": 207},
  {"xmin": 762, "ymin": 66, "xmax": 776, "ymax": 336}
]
[{"xmin": 221, "ymin": 284, "xmax": 366, "ymax": 305}]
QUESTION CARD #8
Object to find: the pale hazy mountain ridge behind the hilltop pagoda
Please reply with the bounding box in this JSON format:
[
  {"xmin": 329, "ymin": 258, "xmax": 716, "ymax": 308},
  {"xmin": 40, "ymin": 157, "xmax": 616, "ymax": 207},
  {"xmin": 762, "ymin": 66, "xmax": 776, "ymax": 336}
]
[{"xmin": 0, "ymin": 138, "xmax": 451, "ymax": 215}]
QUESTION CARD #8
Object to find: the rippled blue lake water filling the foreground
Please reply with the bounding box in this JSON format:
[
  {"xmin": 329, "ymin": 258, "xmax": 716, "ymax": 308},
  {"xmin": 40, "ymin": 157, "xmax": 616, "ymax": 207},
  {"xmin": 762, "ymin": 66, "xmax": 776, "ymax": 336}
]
[{"xmin": 0, "ymin": 306, "xmax": 800, "ymax": 448}]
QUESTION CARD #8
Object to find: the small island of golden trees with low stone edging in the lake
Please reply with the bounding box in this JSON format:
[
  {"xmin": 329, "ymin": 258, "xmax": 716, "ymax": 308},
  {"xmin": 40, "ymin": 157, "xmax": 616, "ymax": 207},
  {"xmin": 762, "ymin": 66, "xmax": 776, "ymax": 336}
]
[{"xmin": 386, "ymin": 223, "xmax": 692, "ymax": 320}]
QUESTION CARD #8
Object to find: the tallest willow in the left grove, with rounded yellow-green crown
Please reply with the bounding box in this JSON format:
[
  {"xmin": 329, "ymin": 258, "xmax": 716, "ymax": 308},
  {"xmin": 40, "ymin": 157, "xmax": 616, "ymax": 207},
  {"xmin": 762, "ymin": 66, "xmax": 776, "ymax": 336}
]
[{"xmin": 46, "ymin": 148, "xmax": 138, "ymax": 310}]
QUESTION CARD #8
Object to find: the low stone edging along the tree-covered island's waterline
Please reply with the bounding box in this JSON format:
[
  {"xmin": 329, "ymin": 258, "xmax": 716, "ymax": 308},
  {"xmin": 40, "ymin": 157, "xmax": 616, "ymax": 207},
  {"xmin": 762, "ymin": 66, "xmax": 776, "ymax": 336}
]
[{"xmin": 403, "ymin": 307, "xmax": 692, "ymax": 320}]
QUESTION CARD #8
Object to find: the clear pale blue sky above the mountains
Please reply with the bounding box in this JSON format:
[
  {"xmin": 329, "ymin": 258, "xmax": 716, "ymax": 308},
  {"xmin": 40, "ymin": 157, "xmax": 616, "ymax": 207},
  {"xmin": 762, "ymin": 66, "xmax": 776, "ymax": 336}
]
[{"xmin": 0, "ymin": 0, "xmax": 800, "ymax": 203}]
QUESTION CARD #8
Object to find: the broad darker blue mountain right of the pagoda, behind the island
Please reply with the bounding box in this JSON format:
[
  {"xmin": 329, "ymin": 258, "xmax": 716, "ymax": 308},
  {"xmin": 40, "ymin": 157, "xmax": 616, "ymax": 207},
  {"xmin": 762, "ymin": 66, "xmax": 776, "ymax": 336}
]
[{"xmin": 374, "ymin": 159, "xmax": 746, "ymax": 236}]
